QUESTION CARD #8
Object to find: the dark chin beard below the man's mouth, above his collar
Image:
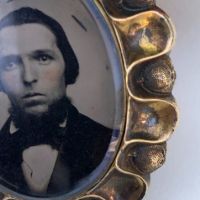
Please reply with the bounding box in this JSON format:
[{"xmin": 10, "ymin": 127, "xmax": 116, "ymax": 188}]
[{"xmin": 9, "ymin": 97, "xmax": 71, "ymax": 132}]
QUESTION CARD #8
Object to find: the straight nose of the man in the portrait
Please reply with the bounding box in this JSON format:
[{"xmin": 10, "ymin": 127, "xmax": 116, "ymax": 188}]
[{"xmin": 22, "ymin": 59, "xmax": 37, "ymax": 85}]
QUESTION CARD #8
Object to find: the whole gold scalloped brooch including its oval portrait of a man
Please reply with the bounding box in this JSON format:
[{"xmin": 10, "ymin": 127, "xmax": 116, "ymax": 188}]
[{"xmin": 0, "ymin": 0, "xmax": 177, "ymax": 200}]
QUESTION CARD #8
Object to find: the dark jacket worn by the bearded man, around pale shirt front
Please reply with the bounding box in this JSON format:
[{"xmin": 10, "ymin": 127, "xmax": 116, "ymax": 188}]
[{"xmin": 0, "ymin": 105, "xmax": 112, "ymax": 196}]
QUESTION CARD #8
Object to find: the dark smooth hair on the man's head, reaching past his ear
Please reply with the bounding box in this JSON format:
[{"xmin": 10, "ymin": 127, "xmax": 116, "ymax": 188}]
[{"xmin": 0, "ymin": 7, "xmax": 79, "ymax": 85}]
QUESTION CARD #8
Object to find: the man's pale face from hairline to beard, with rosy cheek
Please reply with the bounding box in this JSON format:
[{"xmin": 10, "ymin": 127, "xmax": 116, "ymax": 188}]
[{"xmin": 0, "ymin": 24, "xmax": 66, "ymax": 116}]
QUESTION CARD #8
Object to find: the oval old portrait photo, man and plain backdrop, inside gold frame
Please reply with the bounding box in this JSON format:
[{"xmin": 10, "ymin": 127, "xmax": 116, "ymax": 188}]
[{"xmin": 0, "ymin": 1, "xmax": 123, "ymax": 196}]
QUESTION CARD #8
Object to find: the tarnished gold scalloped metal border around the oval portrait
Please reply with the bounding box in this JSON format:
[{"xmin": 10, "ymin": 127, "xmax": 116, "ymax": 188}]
[{"xmin": 1, "ymin": 0, "xmax": 177, "ymax": 200}]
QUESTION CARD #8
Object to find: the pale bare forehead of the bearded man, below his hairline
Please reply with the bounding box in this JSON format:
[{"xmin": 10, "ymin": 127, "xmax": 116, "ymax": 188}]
[{"xmin": 0, "ymin": 23, "xmax": 57, "ymax": 55}]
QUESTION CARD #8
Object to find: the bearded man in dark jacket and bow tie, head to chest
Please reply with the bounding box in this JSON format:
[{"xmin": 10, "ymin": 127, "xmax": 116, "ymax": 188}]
[{"xmin": 0, "ymin": 1, "xmax": 117, "ymax": 196}]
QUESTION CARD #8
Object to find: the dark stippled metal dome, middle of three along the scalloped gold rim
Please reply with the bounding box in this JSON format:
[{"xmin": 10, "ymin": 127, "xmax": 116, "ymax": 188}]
[{"xmin": 128, "ymin": 56, "xmax": 176, "ymax": 97}]
